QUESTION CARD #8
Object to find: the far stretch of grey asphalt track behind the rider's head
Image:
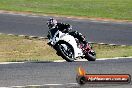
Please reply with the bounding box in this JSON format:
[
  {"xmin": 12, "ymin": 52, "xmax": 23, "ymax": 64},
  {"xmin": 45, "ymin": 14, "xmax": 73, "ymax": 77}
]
[{"xmin": 0, "ymin": 13, "xmax": 132, "ymax": 45}]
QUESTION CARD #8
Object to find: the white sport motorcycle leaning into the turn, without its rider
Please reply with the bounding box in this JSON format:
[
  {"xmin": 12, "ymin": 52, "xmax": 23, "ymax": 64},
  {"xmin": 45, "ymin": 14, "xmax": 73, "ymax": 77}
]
[{"xmin": 47, "ymin": 29, "xmax": 96, "ymax": 62}]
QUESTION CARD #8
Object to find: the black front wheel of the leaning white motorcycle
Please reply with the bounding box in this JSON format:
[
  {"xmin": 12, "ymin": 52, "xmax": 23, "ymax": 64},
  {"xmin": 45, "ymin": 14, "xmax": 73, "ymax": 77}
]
[{"xmin": 57, "ymin": 42, "xmax": 75, "ymax": 62}]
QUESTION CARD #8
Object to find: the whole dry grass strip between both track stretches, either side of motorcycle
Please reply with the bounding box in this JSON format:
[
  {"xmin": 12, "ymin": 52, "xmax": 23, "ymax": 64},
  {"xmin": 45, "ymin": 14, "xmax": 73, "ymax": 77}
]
[{"xmin": 0, "ymin": 34, "xmax": 132, "ymax": 62}]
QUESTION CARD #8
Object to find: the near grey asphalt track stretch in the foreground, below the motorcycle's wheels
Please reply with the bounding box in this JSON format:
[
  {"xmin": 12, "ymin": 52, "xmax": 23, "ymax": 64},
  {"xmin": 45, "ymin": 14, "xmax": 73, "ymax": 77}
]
[{"xmin": 0, "ymin": 59, "xmax": 132, "ymax": 88}]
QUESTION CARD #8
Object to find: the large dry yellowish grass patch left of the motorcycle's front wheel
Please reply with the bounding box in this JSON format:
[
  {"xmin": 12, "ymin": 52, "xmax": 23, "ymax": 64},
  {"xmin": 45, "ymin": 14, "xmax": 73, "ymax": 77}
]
[{"xmin": 0, "ymin": 34, "xmax": 60, "ymax": 62}]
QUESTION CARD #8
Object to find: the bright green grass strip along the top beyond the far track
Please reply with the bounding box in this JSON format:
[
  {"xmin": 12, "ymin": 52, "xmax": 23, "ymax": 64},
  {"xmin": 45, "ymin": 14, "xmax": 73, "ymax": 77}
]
[{"xmin": 0, "ymin": 0, "xmax": 132, "ymax": 20}]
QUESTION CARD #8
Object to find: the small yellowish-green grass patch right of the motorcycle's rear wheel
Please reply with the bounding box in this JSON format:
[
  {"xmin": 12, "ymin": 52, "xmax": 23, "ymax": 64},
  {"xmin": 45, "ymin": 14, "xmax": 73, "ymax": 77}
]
[{"xmin": 93, "ymin": 44, "xmax": 132, "ymax": 58}]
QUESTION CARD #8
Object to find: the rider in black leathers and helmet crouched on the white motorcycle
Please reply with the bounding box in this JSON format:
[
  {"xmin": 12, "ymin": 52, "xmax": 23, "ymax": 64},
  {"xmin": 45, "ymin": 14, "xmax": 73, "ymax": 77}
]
[{"xmin": 47, "ymin": 18, "xmax": 87, "ymax": 48}]
